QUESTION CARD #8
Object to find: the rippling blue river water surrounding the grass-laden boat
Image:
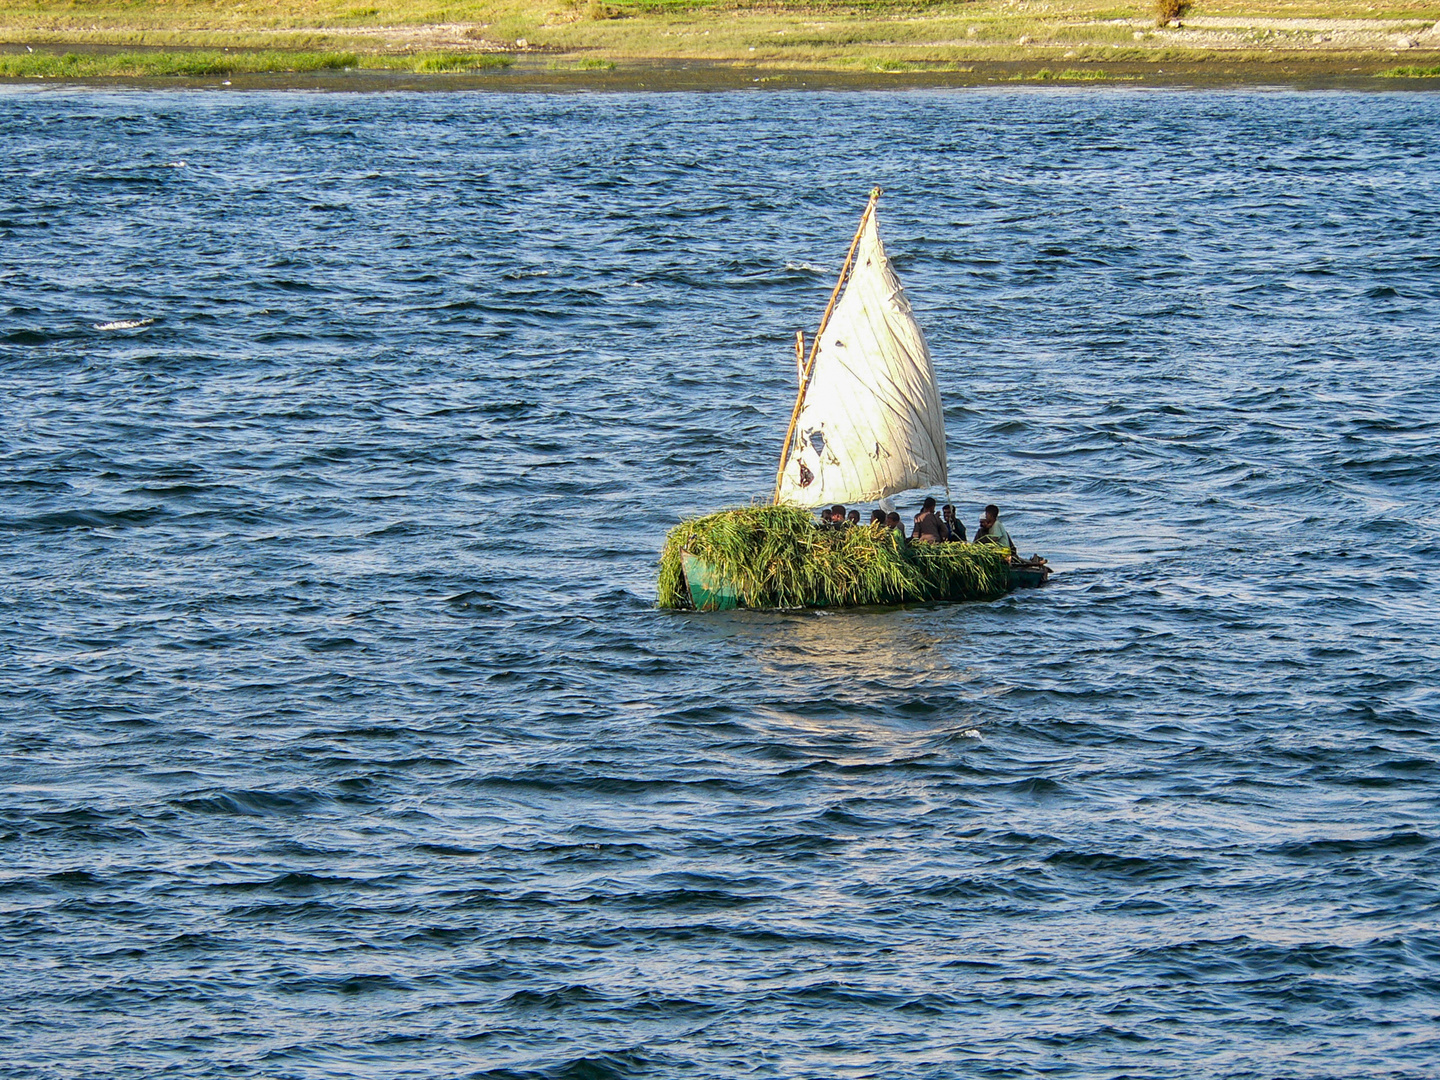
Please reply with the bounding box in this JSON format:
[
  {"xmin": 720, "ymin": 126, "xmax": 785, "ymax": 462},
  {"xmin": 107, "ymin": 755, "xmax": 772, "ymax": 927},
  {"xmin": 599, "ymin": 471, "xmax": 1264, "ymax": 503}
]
[{"xmin": 0, "ymin": 89, "xmax": 1440, "ymax": 1080}]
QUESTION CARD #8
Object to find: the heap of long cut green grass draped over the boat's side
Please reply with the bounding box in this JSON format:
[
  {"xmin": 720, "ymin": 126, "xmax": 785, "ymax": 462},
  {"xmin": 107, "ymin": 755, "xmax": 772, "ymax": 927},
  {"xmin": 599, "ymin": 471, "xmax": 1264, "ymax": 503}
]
[{"xmin": 658, "ymin": 507, "xmax": 1008, "ymax": 608}]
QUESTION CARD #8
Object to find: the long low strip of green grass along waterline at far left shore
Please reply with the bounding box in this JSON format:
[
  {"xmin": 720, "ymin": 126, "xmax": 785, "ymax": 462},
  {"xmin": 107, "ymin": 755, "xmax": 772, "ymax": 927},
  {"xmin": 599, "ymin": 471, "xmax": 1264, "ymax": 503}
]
[{"xmin": 0, "ymin": 49, "xmax": 513, "ymax": 79}]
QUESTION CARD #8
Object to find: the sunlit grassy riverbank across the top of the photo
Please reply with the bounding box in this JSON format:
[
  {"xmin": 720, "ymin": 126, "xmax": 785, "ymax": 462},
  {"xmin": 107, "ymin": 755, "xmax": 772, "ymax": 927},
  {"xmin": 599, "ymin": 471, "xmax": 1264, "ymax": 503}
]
[{"xmin": 0, "ymin": 0, "xmax": 1440, "ymax": 81}]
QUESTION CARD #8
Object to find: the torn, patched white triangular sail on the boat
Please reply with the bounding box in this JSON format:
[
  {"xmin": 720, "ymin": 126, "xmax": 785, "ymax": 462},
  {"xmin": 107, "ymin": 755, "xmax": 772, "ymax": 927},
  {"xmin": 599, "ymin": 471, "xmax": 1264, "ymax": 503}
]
[{"xmin": 779, "ymin": 212, "xmax": 948, "ymax": 507}]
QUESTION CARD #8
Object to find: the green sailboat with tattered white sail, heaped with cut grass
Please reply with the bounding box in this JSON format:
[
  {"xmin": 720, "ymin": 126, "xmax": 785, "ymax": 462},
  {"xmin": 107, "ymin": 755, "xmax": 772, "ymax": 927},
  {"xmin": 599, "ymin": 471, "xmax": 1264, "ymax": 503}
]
[{"xmin": 660, "ymin": 187, "xmax": 1050, "ymax": 611}]
